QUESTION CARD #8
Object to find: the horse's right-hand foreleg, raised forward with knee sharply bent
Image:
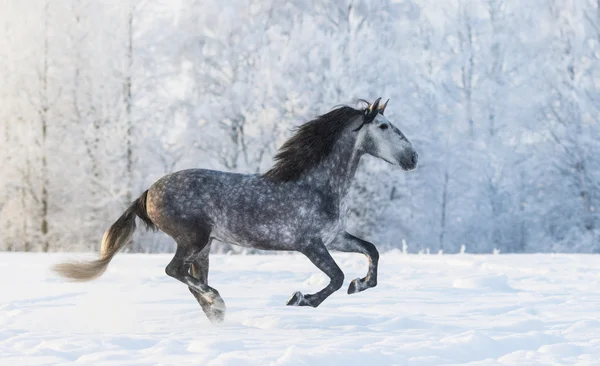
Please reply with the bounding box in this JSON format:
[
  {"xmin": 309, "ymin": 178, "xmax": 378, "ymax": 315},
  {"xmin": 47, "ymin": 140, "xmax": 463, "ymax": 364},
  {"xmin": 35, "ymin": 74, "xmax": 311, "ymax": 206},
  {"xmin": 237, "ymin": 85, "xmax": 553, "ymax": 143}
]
[{"xmin": 328, "ymin": 233, "xmax": 379, "ymax": 294}]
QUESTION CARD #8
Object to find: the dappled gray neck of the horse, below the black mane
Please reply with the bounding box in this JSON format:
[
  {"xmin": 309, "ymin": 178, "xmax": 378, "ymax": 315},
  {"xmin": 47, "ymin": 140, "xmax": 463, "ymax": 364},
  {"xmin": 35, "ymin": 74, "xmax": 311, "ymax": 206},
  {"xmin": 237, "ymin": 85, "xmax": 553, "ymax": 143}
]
[{"xmin": 304, "ymin": 134, "xmax": 362, "ymax": 203}]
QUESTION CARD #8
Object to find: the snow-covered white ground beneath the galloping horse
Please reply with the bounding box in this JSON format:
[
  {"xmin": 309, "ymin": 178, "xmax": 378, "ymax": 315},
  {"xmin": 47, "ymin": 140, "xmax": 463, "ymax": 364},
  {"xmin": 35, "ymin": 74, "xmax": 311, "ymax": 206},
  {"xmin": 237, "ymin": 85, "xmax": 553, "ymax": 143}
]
[{"xmin": 0, "ymin": 252, "xmax": 600, "ymax": 366}]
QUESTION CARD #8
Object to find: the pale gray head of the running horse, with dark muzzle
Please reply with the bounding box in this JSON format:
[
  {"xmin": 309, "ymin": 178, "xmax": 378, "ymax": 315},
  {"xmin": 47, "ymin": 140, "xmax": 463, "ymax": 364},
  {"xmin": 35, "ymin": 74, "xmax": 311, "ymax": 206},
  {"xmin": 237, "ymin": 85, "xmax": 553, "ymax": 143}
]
[{"xmin": 355, "ymin": 98, "xmax": 419, "ymax": 170}]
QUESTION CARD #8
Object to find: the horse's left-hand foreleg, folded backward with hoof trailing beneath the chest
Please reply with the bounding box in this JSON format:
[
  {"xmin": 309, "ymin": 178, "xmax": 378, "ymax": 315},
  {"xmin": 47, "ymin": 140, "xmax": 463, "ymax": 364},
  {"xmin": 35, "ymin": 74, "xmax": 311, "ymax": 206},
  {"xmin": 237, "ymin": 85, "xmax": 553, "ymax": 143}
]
[{"xmin": 287, "ymin": 240, "xmax": 344, "ymax": 308}]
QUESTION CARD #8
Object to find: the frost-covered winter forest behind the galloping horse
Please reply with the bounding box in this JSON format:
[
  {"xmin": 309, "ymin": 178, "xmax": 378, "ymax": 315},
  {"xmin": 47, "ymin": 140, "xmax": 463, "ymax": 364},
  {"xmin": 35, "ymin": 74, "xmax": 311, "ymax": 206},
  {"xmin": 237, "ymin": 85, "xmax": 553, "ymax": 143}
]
[{"xmin": 0, "ymin": 0, "xmax": 600, "ymax": 253}]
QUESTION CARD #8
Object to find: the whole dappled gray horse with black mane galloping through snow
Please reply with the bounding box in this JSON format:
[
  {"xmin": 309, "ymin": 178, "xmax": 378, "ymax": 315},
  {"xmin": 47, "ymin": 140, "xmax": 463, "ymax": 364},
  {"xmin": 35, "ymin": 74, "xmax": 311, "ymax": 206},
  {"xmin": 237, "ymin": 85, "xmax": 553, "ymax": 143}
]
[{"xmin": 55, "ymin": 98, "xmax": 417, "ymax": 322}]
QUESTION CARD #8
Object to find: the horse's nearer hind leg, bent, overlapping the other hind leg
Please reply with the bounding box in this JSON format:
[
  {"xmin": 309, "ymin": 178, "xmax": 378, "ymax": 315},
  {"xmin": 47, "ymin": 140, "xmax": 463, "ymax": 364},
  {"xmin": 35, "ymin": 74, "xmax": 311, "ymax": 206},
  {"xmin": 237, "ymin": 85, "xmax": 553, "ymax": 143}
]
[{"xmin": 165, "ymin": 238, "xmax": 225, "ymax": 321}]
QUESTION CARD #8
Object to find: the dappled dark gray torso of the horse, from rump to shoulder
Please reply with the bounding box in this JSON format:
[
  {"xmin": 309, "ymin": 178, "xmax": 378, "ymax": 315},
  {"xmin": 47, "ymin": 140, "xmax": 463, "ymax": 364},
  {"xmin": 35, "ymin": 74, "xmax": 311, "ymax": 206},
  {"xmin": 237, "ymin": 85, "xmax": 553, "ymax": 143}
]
[{"xmin": 147, "ymin": 169, "xmax": 330, "ymax": 249}]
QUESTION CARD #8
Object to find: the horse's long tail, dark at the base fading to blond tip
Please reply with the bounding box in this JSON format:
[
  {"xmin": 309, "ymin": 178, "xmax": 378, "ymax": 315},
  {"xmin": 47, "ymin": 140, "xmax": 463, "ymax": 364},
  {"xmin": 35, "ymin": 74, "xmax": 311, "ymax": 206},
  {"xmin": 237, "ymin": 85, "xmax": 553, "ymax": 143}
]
[{"xmin": 54, "ymin": 191, "xmax": 156, "ymax": 281}]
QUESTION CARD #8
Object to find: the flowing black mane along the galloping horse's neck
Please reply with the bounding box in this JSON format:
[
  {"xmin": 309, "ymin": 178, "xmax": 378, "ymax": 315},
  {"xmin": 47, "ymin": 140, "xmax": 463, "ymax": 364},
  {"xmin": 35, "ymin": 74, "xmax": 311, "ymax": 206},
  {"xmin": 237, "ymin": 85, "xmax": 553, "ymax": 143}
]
[{"xmin": 263, "ymin": 106, "xmax": 365, "ymax": 182}]
